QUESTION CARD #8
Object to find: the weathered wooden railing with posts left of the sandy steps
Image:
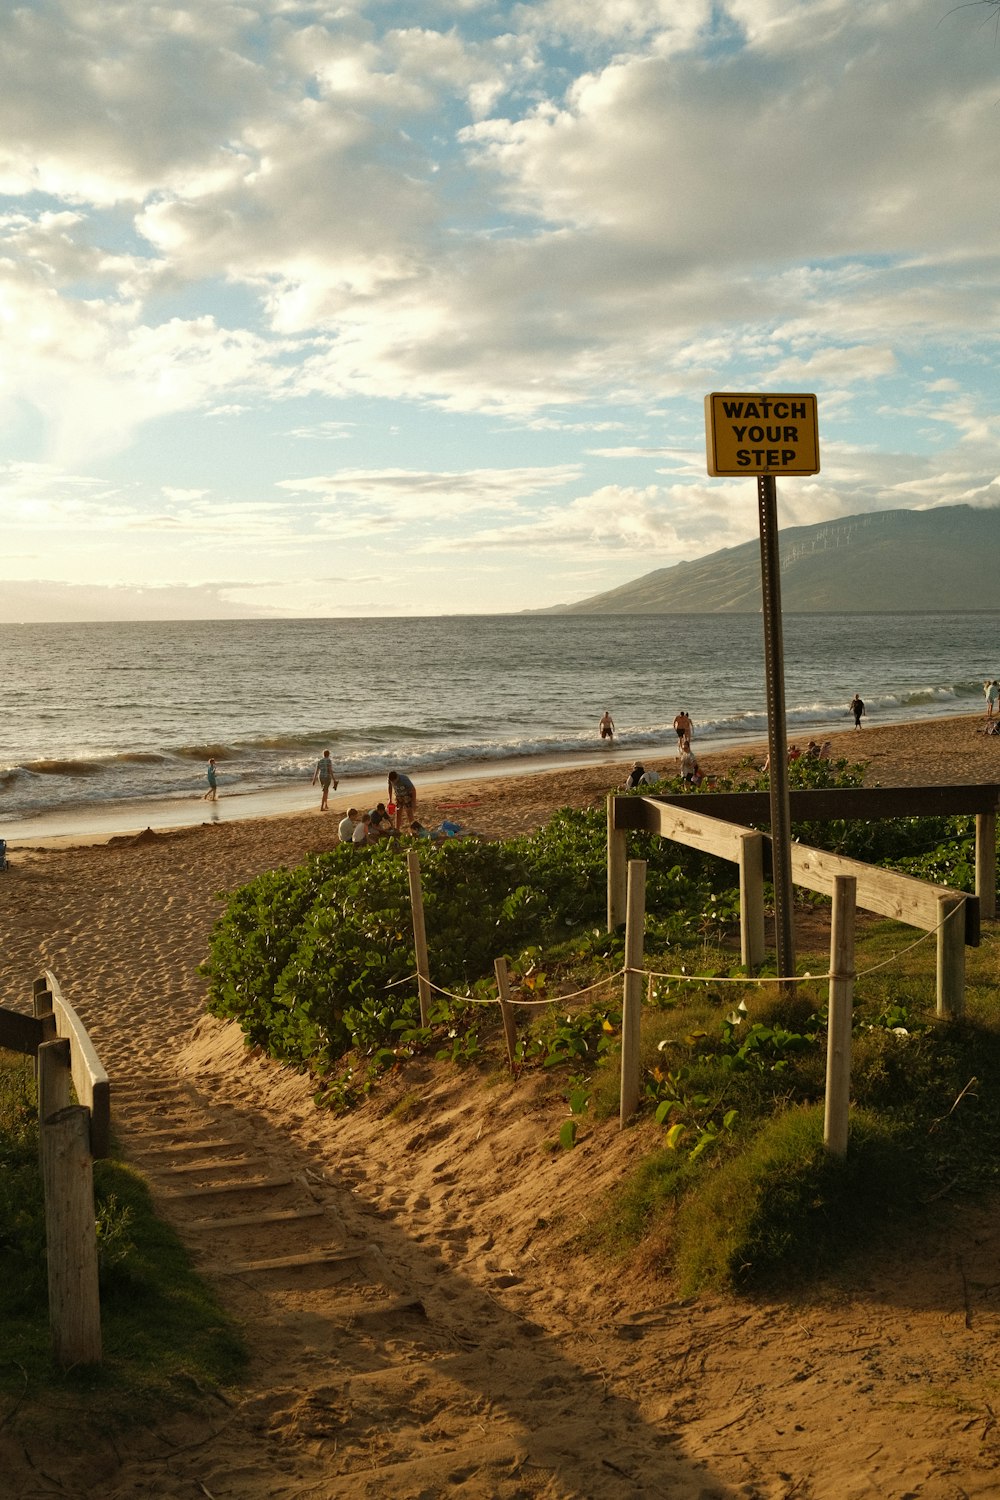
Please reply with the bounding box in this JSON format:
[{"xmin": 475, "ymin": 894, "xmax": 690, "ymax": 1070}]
[{"xmin": 0, "ymin": 969, "xmax": 111, "ymax": 1368}]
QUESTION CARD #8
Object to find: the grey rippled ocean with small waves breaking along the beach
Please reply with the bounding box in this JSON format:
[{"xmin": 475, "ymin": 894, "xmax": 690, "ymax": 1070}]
[{"xmin": 0, "ymin": 612, "xmax": 1000, "ymax": 837}]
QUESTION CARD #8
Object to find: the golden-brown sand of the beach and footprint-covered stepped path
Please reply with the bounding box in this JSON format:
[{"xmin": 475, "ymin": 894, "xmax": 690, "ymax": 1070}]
[{"xmin": 0, "ymin": 717, "xmax": 1000, "ymax": 1500}]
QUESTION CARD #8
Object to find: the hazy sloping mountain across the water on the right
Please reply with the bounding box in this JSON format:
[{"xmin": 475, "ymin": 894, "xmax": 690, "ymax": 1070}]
[{"xmin": 532, "ymin": 506, "xmax": 1000, "ymax": 615}]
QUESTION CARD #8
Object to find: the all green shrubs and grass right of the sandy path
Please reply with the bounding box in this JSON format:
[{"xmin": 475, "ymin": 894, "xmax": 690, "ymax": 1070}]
[{"xmin": 205, "ymin": 761, "xmax": 1000, "ymax": 1292}]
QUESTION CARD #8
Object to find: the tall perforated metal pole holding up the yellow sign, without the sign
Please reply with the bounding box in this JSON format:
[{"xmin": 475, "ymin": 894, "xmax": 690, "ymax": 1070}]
[{"xmin": 757, "ymin": 474, "xmax": 795, "ymax": 975}]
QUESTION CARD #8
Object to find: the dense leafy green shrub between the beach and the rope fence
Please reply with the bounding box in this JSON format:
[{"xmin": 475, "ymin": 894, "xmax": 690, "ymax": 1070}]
[{"xmin": 205, "ymin": 809, "xmax": 743, "ymax": 1077}]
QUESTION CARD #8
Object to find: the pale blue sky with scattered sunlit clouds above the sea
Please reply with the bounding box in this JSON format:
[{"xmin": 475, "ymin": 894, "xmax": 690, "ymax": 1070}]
[{"xmin": 0, "ymin": 0, "xmax": 1000, "ymax": 623}]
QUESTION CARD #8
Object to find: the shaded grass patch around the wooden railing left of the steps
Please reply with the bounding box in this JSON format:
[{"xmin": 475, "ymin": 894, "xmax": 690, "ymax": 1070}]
[{"xmin": 0, "ymin": 1052, "xmax": 246, "ymax": 1410}]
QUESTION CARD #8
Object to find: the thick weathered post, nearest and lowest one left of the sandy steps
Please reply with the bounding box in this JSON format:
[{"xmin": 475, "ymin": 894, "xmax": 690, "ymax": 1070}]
[{"xmin": 40, "ymin": 1104, "xmax": 100, "ymax": 1370}]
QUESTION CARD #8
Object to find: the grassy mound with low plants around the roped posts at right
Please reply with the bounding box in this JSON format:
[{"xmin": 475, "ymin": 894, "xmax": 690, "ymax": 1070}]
[{"xmin": 585, "ymin": 923, "xmax": 1000, "ymax": 1295}]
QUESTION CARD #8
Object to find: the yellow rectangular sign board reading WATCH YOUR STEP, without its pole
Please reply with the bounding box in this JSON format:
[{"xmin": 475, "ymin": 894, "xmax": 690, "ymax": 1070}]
[{"xmin": 705, "ymin": 390, "xmax": 820, "ymax": 476}]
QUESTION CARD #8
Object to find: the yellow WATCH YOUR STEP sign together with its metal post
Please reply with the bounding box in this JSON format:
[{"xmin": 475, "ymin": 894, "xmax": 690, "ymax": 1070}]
[{"xmin": 705, "ymin": 392, "xmax": 820, "ymax": 981}]
